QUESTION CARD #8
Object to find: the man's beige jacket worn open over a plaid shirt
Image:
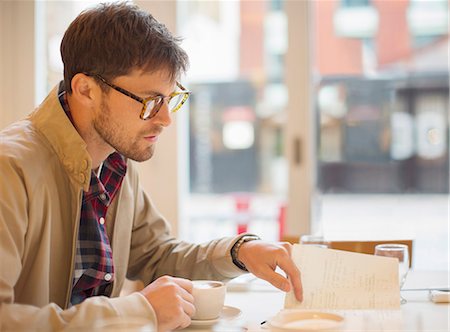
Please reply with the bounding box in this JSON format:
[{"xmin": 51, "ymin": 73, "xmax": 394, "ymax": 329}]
[{"xmin": 0, "ymin": 89, "xmax": 242, "ymax": 331}]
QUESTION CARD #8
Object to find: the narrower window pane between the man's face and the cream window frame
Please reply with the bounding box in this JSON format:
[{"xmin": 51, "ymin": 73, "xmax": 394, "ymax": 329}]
[{"xmin": 178, "ymin": 0, "xmax": 287, "ymax": 241}]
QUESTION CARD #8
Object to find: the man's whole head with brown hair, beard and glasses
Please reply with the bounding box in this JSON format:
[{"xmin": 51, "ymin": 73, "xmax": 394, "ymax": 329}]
[{"xmin": 61, "ymin": 3, "xmax": 189, "ymax": 166}]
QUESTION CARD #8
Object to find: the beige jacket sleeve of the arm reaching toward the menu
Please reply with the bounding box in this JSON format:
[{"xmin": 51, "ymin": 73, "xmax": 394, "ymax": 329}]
[{"xmin": 127, "ymin": 164, "xmax": 248, "ymax": 284}]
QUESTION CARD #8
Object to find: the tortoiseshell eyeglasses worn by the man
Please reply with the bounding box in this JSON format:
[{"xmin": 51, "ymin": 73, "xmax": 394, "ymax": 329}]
[{"xmin": 85, "ymin": 73, "xmax": 191, "ymax": 120}]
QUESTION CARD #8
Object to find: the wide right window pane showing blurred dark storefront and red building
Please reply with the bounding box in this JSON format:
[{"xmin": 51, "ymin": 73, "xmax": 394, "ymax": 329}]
[{"xmin": 311, "ymin": 0, "xmax": 449, "ymax": 269}]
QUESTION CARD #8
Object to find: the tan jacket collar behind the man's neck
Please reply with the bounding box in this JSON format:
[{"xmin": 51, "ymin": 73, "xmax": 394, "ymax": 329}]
[{"xmin": 29, "ymin": 87, "xmax": 92, "ymax": 191}]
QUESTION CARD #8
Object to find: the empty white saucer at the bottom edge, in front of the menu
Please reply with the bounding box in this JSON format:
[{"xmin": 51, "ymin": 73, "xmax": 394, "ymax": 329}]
[{"xmin": 269, "ymin": 310, "xmax": 344, "ymax": 331}]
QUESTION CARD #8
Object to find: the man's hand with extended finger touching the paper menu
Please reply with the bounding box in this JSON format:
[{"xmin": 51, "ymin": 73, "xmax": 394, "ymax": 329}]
[{"xmin": 237, "ymin": 240, "xmax": 303, "ymax": 302}]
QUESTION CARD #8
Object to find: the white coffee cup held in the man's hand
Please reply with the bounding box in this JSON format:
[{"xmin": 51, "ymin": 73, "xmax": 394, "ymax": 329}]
[{"xmin": 192, "ymin": 280, "xmax": 226, "ymax": 320}]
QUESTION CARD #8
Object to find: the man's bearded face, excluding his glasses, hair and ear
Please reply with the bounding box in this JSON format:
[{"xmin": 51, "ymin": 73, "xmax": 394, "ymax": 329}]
[{"xmin": 92, "ymin": 71, "xmax": 175, "ymax": 161}]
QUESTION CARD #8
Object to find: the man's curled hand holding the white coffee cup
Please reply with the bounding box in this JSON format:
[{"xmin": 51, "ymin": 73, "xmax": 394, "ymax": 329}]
[{"xmin": 141, "ymin": 276, "xmax": 195, "ymax": 331}]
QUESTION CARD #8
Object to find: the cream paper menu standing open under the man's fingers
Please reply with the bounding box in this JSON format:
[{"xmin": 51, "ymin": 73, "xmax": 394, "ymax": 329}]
[{"xmin": 285, "ymin": 244, "xmax": 400, "ymax": 309}]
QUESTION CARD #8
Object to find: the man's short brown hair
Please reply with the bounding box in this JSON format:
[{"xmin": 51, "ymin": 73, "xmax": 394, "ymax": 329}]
[{"xmin": 61, "ymin": 2, "xmax": 188, "ymax": 93}]
